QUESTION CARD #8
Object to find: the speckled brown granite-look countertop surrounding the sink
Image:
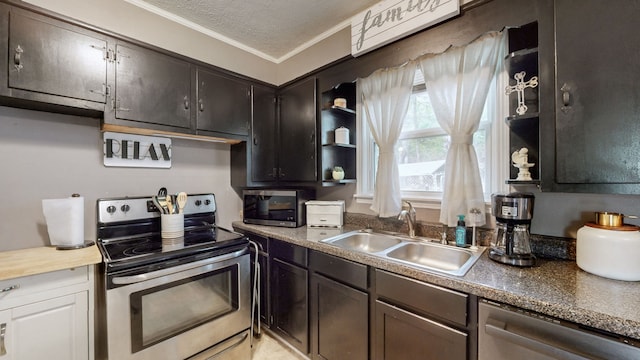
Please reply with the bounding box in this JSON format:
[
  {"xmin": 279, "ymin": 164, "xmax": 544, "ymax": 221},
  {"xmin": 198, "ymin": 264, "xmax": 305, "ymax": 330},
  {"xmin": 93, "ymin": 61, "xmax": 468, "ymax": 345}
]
[{"xmin": 233, "ymin": 222, "xmax": 640, "ymax": 340}]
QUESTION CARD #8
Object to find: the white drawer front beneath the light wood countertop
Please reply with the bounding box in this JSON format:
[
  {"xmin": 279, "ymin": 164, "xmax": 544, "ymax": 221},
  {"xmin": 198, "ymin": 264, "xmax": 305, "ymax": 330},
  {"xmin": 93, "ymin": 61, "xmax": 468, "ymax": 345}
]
[{"xmin": 0, "ymin": 266, "xmax": 89, "ymax": 308}]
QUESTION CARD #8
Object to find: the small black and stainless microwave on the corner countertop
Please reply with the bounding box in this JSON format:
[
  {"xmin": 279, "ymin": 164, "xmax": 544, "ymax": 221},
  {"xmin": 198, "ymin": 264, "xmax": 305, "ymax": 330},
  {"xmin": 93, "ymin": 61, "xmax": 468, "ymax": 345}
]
[{"xmin": 242, "ymin": 189, "xmax": 314, "ymax": 227}]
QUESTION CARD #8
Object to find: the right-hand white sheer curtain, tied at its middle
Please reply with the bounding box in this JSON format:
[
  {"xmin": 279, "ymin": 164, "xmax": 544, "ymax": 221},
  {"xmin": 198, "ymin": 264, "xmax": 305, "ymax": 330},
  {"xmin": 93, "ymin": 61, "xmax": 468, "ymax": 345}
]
[{"xmin": 418, "ymin": 32, "xmax": 506, "ymax": 226}]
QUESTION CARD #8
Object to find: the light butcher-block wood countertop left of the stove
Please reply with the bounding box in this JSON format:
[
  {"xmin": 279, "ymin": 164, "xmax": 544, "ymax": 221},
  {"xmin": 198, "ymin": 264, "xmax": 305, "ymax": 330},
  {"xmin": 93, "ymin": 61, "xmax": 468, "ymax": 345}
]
[{"xmin": 0, "ymin": 245, "xmax": 102, "ymax": 280}]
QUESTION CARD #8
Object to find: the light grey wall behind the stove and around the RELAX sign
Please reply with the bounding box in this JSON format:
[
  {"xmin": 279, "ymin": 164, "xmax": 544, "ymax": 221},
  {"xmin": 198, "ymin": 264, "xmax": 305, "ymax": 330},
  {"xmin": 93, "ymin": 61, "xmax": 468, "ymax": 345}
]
[{"xmin": 0, "ymin": 107, "xmax": 241, "ymax": 251}]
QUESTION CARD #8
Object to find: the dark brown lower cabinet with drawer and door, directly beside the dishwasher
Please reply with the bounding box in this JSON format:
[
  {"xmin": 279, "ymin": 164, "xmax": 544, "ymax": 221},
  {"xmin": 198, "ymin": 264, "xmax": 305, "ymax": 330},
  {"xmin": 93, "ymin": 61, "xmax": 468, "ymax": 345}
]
[{"xmin": 373, "ymin": 269, "xmax": 478, "ymax": 360}]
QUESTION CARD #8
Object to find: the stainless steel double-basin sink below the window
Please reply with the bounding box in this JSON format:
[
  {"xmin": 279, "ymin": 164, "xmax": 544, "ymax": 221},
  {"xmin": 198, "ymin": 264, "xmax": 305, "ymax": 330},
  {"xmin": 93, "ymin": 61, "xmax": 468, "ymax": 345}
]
[{"xmin": 323, "ymin": 230, "xmax": 485, "ymax": 276}]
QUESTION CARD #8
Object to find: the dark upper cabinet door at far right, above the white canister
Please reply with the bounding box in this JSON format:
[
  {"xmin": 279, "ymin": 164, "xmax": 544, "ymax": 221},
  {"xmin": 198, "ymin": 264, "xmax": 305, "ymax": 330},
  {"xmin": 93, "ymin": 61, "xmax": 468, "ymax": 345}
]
[{"xmin": 555, "ymin": 0, "xmax": 640, "ymax": 188}]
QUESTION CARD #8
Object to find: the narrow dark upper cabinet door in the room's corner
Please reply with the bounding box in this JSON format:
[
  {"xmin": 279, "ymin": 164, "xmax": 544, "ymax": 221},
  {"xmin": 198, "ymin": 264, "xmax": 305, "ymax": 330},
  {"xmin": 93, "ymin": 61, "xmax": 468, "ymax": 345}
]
[{"xmin": 250, "ymin": 86, "xmax": 278, "ymax": 182}]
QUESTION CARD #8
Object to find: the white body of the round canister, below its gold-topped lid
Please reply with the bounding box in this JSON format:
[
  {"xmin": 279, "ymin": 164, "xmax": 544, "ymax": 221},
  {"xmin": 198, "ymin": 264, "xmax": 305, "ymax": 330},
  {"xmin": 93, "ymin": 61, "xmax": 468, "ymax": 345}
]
[{"xmin": 576, "ymin": 225, "xmax": 640, "ymax": 281}]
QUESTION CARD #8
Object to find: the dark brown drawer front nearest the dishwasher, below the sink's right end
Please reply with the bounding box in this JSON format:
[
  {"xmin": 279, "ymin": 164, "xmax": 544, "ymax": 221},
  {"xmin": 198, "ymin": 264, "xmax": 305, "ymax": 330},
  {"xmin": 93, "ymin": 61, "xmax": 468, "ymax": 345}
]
[{"xmin": 376, "ymin": 270, "xmax": 469, "ymax": 326}]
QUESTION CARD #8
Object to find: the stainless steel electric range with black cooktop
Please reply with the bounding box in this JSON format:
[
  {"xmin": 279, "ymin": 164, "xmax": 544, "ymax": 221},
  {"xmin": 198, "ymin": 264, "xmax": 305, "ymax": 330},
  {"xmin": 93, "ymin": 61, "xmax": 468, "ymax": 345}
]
[{"xmin": 96, "ymin": 194, "xmax": 251, "ymax": 360}]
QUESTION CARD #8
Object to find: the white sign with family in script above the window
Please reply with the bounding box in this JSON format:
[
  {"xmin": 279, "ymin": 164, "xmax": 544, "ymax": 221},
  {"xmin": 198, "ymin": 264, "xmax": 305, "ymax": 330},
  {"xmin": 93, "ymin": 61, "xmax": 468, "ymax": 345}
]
[{"xmin": 351, "ymin": 0, "xmax": 460, "ymax": 56}]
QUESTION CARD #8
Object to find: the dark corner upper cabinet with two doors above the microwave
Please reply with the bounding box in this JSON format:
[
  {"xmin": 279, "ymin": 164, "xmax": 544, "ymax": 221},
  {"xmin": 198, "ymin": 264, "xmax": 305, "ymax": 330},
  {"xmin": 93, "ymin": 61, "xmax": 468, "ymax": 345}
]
[{"xmin": 231, "ymin": 77, "xmax": 318, "ymax": 187}]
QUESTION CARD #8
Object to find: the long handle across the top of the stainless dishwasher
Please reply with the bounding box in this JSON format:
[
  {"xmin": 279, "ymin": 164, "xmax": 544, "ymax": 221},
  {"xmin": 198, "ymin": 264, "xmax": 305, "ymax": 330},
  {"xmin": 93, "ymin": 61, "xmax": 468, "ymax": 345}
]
[{"xmin": 484, "ymin": 318, "xmax": 604, "ymax": 360}]
